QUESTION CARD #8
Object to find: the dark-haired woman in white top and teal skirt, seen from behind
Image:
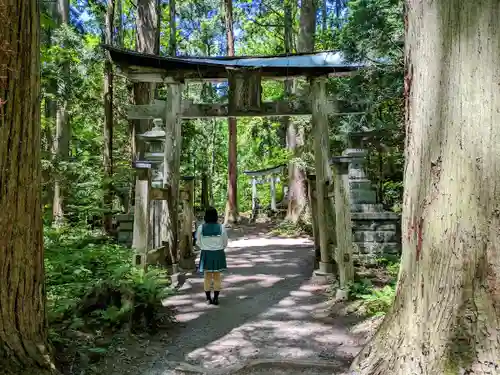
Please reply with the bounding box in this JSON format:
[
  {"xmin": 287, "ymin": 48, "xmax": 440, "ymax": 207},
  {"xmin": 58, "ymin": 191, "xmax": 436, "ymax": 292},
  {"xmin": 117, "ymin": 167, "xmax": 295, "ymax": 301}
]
[{"xmin": 196, "ymin": 207, "xmax": 228, "ymax": 305}]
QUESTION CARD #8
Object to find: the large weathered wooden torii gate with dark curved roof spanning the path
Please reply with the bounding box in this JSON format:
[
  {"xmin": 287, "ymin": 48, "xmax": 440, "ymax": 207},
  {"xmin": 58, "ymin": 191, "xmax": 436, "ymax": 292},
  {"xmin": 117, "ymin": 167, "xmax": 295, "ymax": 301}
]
[{"xmin": 104, "ymin": 46, "xmax": 372, "ymax": 280}]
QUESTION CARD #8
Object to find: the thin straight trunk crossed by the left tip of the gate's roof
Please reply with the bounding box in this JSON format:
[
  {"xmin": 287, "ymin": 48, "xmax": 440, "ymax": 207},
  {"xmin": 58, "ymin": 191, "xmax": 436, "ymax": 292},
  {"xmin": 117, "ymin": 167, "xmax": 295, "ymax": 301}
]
[{"xmin": 103, "ymin": 0, "xmax": 115, "ymax": 234}]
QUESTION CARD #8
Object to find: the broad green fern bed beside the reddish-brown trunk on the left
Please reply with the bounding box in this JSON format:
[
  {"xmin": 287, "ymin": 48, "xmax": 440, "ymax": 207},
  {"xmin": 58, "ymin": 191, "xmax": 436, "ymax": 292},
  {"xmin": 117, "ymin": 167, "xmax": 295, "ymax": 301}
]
[{"xmin": 45, "ymin": 228, "xmax": 177, "ymax": 374}]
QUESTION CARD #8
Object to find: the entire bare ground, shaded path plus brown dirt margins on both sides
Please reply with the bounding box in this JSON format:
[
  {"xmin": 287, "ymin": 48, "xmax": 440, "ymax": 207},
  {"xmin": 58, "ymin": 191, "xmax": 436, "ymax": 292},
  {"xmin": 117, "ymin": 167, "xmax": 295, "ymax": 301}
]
[{"xmin": 94, "ymin": 224, "xmax": 382, "ymax": 375}]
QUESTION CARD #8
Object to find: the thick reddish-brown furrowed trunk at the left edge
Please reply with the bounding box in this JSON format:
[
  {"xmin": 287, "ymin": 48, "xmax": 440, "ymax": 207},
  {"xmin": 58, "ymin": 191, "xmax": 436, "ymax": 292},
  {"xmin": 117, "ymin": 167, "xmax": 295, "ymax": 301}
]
[{"xmin": 0, "ymin": 0, "xmax": 53, "ymax": 374}]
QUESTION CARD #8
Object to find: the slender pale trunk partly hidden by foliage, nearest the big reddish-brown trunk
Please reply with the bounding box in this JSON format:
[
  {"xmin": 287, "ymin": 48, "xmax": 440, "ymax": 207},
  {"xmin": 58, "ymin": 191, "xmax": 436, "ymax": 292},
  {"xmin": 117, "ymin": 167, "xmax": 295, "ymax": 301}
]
[{"xmin": 52, "ymin": 0, "xmax": 71, "ymax": 225}]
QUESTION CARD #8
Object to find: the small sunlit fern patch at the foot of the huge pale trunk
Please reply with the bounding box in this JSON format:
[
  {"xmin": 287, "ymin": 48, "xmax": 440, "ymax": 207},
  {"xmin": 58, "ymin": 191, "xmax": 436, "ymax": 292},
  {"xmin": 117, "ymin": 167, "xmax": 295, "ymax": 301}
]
[{"xmin": 349, "ymin": 259, "xmax": 399, "ymax": 316}]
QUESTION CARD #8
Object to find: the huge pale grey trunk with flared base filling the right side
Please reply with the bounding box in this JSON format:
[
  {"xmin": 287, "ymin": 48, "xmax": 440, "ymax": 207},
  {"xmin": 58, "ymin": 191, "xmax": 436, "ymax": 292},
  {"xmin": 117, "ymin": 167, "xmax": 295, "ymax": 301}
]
[{"xmin": 352, "ymin": 0, "xmax": 500, "ymax": 375}]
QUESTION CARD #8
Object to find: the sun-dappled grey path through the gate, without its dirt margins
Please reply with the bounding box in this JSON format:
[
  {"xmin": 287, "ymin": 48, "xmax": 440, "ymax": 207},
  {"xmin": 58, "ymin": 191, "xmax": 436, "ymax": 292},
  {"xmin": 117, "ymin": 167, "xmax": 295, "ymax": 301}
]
[{"xmin": 140, "ymin": 225, "xmax": 360, "ymax": 375}]
